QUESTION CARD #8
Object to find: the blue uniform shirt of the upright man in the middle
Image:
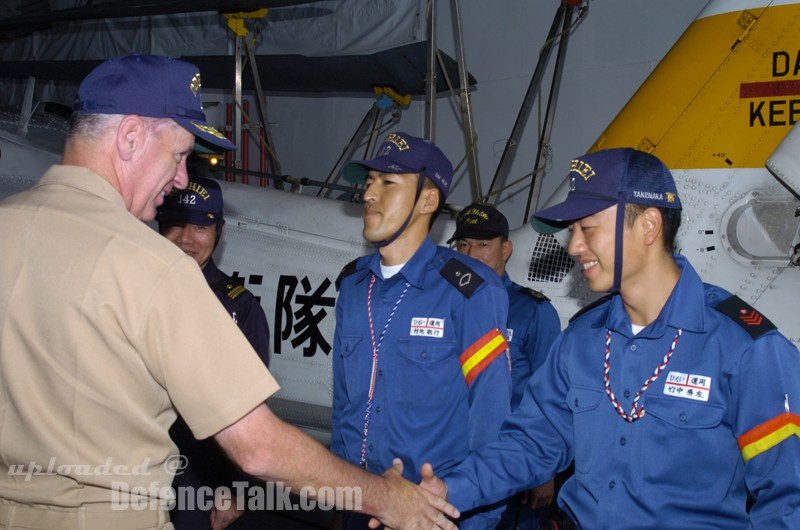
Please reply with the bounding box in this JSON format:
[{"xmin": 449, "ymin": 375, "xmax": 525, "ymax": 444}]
[{"xmin": 331, "ymin": 238, "xmax": 511, "ymax": 528}]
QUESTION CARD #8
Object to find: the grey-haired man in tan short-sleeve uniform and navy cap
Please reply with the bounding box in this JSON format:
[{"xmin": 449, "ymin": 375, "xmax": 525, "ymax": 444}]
[{"xmin": 0, "ymin": 55, "xmax": 457, "ymax": 530}]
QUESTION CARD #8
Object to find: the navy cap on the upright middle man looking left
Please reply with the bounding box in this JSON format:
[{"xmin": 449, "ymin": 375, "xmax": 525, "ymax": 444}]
[{"xmin": 342, "ymin": 132, "xmax": 453, "ymax": 197}]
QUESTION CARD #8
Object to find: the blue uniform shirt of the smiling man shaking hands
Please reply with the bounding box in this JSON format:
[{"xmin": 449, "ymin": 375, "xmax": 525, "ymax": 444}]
[{"xmin": 445, "ymin": 255, "xmax": 800, "ymax": 530}]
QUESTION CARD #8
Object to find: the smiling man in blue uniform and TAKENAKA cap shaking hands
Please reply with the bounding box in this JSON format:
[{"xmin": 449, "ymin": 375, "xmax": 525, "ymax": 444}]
[{"xmin": 442, "ymin": 149, "xmax": 800, "ymax": 530}]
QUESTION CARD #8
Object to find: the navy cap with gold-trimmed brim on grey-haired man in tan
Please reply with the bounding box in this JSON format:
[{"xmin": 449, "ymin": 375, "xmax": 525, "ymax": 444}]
[{"xmin": 73, "ymin": 54, "xmax": 236, "ymax": 150}]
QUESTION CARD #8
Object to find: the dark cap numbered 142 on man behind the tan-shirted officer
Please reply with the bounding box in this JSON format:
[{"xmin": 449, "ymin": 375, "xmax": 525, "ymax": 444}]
[{"xmin": 156, "ymin": 173, "xmax": 223, "ymax": 226}]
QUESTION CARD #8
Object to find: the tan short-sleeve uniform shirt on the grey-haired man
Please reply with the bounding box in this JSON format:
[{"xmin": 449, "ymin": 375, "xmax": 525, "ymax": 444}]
[{"xmin": 0, "ymin": 166, "xmax": 278, "ymax": 507}]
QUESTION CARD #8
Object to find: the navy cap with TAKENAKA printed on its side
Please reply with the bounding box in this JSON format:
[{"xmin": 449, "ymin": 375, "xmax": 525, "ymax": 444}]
[{"xmin": 530, "ymin": 147, "xmax": 682, "ymax": 234}]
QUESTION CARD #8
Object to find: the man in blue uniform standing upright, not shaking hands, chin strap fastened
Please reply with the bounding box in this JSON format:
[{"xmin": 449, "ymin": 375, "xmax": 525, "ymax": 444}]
[{"xmin": 331, "ymin": 133, "xmax": 511, "ymax": 529}]
